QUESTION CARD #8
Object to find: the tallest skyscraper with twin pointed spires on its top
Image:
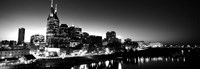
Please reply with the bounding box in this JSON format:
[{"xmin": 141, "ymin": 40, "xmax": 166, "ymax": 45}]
[{"xmin": 46, "ymin": 0, "xmax": 59, "ymax": 47}]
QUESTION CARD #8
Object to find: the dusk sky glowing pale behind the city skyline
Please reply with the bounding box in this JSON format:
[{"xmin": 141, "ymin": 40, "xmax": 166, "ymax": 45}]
[{"xmin": 0, "ymin": 0, "xmax": 200, "ymax": 44}]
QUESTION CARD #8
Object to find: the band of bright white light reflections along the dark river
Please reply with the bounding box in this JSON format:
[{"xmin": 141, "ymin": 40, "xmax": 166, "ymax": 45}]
[{"xmin": 71, "ymin": 57, "xmax": 185, "ymax": 69}]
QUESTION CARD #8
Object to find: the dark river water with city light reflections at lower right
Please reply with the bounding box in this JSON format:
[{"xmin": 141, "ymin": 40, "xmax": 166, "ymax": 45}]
[{"xmin": 71, "ymin": 49, "xmax": 200, "ymax": 69}]
